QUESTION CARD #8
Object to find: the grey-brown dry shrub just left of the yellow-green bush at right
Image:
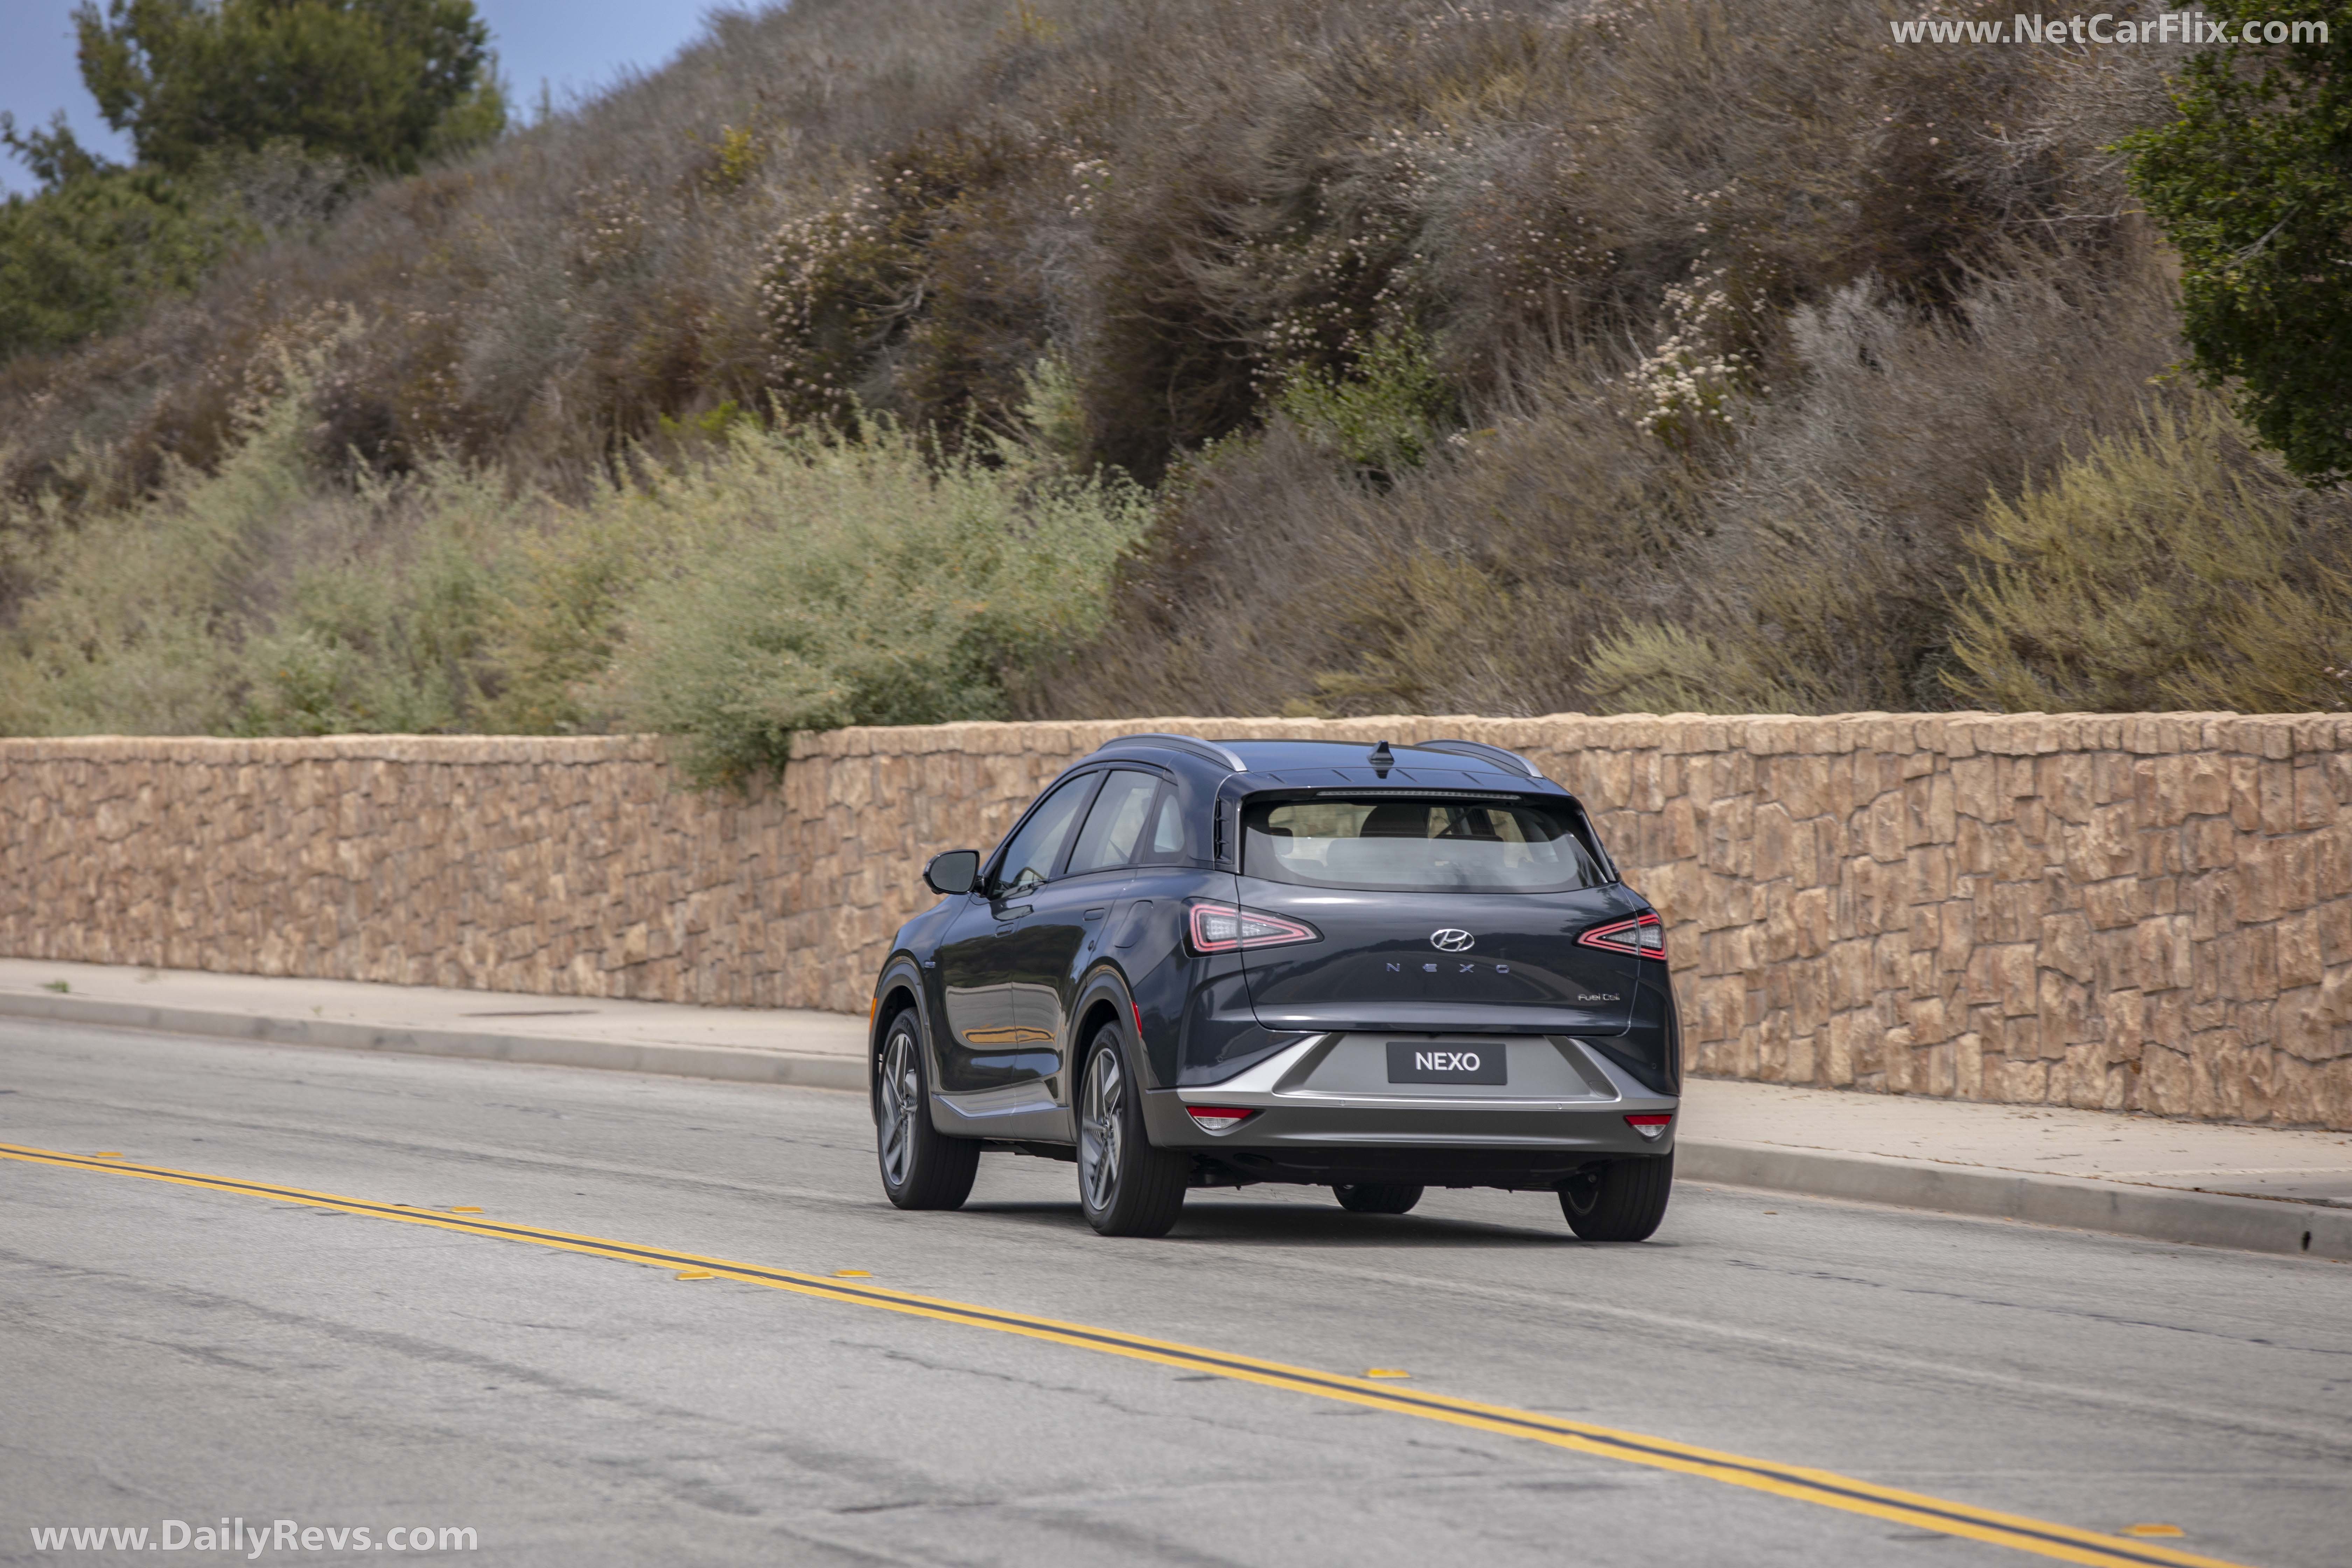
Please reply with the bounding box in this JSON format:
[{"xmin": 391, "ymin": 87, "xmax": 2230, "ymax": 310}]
[{"xmin": 1585, "ymin": 240, "xmax": 2178, "ymax": 712}]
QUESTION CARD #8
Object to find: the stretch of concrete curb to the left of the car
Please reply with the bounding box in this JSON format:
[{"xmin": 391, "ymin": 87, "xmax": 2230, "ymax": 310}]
[{"xmin": 0, "ymin": 992, "xmax": 866, "ymax": 1093}]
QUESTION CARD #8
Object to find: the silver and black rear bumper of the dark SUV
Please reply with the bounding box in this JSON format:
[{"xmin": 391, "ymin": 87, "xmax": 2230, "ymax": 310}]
[{"xmin": 1143, "ymin": 1034, "xmax": 1679, "ymax": 1187}]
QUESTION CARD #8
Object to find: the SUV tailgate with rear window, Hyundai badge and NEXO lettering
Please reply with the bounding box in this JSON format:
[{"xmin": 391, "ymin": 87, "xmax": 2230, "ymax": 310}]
[{"xmin": 1239, "ymin": 790, "xmax": 1642, "ymax": 1034}]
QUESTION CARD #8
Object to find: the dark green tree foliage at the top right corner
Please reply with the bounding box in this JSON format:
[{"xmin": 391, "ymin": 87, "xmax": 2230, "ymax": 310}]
[{"xmin": 2124, "ymin": 0, "xmax": 2352, "ymax": 484}]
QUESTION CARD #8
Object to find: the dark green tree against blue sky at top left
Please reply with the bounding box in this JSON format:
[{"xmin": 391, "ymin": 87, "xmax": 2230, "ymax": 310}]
[{"xmin": 73, "ymin": 0, "xmax": 506, "ymax": 174}]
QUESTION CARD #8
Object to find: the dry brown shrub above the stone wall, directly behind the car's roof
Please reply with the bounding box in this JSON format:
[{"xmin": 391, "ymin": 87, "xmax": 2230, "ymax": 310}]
[{"xmin": 1026, "ymin": 374, "xmax": 1701, "ymax": 717}]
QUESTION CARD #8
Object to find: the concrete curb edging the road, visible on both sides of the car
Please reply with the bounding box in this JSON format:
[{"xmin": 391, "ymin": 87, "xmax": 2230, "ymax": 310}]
[{"xmin": 0, "ymin": 992, "xmax": 2352, "ymax": 1260}]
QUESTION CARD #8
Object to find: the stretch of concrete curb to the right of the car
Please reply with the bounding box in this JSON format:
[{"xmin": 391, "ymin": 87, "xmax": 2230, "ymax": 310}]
[{"xmin": 1675, "ymin": 1138, "xmax": 2352, "ymax": 1260}]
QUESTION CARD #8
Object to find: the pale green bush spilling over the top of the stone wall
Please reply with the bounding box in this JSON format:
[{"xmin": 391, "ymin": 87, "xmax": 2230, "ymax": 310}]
[{"xmin": 609, "ymin": 421, "xmax": 1148, "ymax": 783}]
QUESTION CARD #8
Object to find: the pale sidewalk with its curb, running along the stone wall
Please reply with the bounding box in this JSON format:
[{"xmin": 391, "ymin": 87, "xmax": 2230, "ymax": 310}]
[{"xmin": 0, "ymin": 959, "xmax": 2352, "ymax": 1260}]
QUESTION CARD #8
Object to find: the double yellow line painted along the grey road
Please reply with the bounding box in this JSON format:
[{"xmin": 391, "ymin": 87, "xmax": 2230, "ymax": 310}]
[{"xmin": 0, "ymin": 1142, "xmax": 2267, "ymax": 1568}]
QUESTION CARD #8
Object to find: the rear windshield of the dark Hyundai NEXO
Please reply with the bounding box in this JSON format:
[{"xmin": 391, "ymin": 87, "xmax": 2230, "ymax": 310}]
[{"xmin": 1242, "ymin": 797, "xmax": 1602, "ymax": 893}]
